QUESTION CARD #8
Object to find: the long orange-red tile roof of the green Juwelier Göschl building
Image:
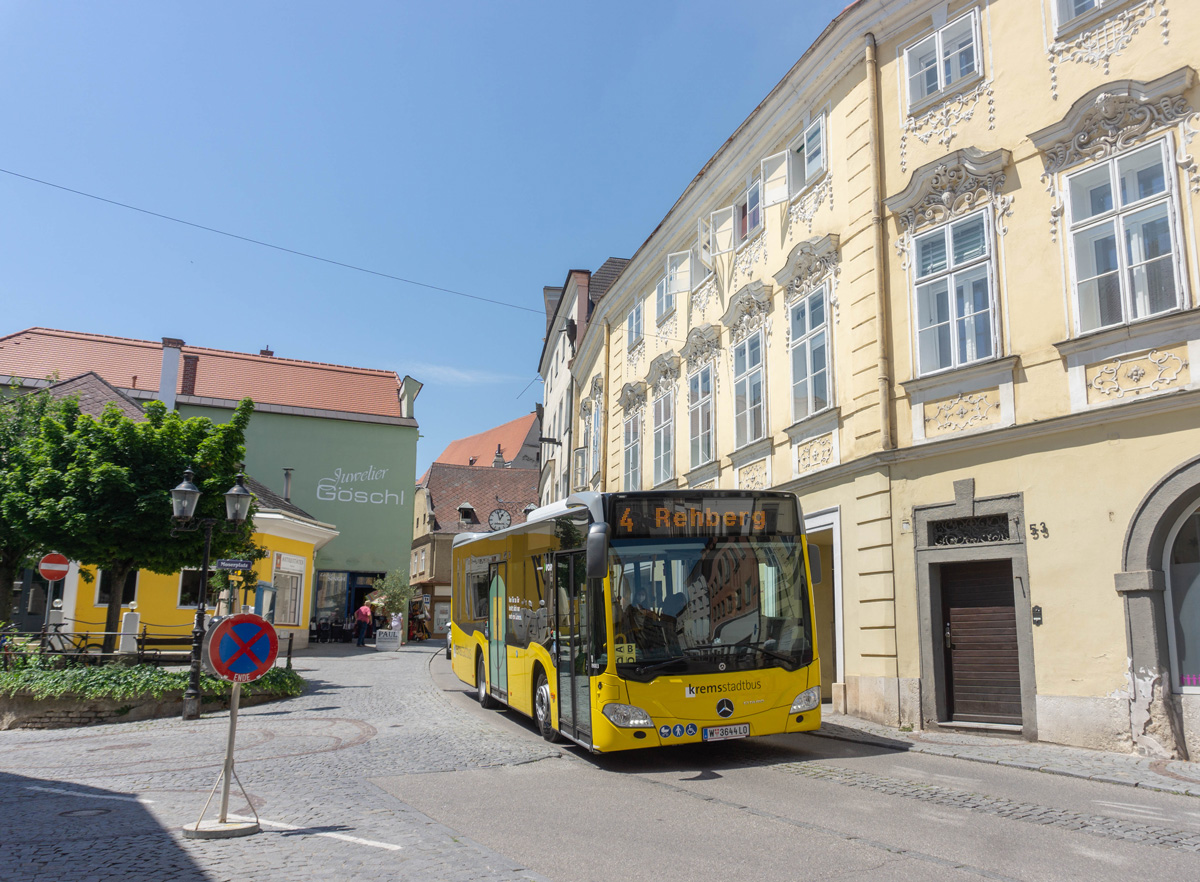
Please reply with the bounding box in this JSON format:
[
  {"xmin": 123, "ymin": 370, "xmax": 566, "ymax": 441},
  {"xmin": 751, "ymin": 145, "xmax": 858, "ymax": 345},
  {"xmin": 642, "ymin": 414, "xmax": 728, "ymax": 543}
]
[{"xmin": 0, "ymin": 328, "xmax": 408, "ymax": 420}]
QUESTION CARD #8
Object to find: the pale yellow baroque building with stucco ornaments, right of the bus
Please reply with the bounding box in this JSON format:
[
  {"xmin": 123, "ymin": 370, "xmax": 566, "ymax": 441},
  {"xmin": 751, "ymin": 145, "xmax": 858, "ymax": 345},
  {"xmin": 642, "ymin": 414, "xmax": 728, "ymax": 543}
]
[{"xmin": 556, "ymin": 0, "xmax": 1200, "ymax": 756}]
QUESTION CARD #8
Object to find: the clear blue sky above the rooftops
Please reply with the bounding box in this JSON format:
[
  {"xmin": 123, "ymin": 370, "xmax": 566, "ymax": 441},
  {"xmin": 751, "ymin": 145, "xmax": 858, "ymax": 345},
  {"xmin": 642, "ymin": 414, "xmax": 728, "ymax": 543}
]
[{"xmin": 0, "ymin": 0, "xmax": 846, "ymax": 474}]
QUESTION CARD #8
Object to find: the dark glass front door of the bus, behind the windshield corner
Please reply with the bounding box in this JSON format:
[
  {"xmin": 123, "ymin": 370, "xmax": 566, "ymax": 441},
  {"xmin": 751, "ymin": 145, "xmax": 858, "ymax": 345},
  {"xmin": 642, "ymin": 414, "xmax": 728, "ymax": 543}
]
[{"xmin": 554, "ymin": 551, "xmax": 592, "ymax": 746}]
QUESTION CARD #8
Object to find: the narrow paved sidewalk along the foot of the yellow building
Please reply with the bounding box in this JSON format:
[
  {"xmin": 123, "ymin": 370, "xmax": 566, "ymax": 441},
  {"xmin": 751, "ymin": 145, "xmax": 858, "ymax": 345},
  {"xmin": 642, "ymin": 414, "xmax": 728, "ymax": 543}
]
[{"xmin": 812, "ymin": 710, "xmax": 1200, "ymax": 797}]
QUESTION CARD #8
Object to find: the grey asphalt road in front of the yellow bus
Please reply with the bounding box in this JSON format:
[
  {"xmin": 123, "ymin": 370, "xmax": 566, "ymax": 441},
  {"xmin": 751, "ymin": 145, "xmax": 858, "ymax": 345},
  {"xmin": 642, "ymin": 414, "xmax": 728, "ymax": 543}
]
[{"xmin": 403, "ymin": 656, "xmax": 1200, "ymax": 882}]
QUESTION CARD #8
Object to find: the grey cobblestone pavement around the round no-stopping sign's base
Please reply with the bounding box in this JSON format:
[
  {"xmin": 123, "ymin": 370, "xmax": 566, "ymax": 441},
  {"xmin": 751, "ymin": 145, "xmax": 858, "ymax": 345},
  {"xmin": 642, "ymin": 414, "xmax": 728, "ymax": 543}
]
[{"xmin": 0, "ymin": 644, "xmax": 562, "ymax": 882}]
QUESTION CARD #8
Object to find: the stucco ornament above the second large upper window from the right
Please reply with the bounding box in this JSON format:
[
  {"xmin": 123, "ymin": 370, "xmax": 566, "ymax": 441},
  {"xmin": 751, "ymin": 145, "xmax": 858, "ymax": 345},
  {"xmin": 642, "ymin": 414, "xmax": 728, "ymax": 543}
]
[{"xmin": 884, "ymin": 148, "xmax": 1013, "ymax": 270}]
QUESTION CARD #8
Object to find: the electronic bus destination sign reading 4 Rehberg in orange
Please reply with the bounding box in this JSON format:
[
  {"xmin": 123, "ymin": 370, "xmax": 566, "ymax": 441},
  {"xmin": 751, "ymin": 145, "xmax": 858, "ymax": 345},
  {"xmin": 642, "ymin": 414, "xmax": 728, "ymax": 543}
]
[{"xmin": 610, "ymin": 494, "xmax": 799, "ymax": 539}]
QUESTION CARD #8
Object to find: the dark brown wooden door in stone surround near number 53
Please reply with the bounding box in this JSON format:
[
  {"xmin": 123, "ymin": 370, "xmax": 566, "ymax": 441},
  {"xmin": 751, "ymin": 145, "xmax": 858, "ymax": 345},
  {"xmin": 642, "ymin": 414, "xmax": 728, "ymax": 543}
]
[{"xmin": 941, "ymin": 560, "xmax": 1021, "ymax": 726}]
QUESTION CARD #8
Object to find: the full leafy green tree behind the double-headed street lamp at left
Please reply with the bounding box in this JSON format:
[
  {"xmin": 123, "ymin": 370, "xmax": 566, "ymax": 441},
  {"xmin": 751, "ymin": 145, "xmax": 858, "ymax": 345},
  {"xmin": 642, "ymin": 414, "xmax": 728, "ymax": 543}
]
[{"xmin": 2, "ymin": 398, "xmax": 254, "ymax": 652}]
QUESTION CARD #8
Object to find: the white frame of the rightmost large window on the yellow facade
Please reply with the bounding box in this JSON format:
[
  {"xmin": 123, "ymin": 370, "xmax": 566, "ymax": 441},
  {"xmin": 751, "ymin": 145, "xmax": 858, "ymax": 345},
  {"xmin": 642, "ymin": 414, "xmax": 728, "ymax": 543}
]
[{"xmin": 1062, "ymin": 138, "xmax": 1188, "ymax": 335}]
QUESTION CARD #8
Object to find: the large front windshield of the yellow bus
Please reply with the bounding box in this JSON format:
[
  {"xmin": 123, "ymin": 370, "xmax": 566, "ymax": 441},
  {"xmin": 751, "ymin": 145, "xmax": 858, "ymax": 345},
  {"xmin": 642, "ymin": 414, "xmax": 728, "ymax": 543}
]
[{"xmin": 608, "ymin": 536, "xmax": 814, "ymax": 680}]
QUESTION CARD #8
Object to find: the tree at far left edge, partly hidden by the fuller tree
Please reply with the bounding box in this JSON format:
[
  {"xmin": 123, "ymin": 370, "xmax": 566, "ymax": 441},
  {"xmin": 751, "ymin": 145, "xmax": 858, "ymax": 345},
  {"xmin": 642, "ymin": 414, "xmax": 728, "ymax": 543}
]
[{"xmin": 0, "ymin": 386, "xmax": 72, "ymax": 624}]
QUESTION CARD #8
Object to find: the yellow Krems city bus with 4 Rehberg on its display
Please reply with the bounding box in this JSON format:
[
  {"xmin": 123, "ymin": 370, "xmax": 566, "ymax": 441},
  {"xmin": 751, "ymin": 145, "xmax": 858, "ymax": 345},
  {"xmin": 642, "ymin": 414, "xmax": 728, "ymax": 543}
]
[{"xmin": 450, "ymin": 491, "xmax": 821, "ymax": 752}]
